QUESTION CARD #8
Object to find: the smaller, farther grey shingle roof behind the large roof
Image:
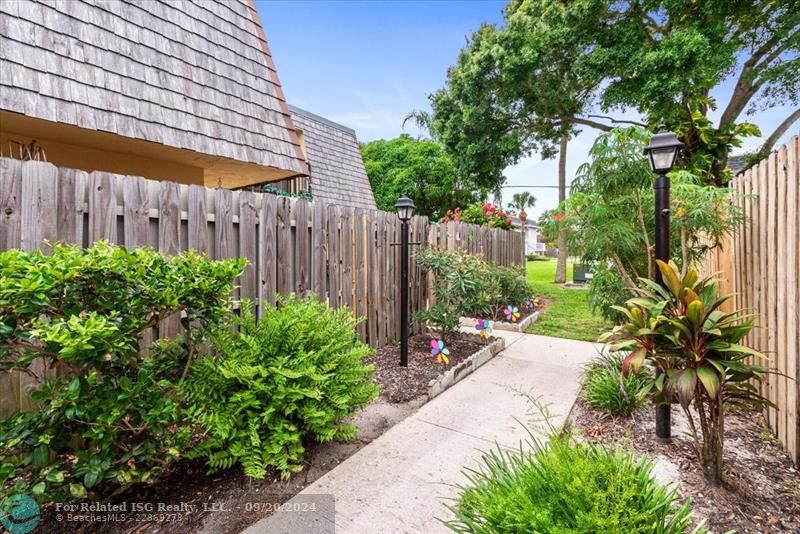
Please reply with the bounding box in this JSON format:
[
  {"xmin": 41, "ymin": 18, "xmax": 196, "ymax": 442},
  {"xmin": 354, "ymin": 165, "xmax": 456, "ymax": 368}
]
[{"xmin": 289, "ymin": 106, "xmax": 377, "ymax": 210}]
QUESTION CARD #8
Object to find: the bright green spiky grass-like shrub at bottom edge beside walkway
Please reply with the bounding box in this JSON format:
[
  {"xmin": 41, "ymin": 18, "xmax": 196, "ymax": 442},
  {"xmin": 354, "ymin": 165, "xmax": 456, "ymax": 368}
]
[{"xmin": 445, "ymin": 436, "xmax": 692, "ymax": 534}]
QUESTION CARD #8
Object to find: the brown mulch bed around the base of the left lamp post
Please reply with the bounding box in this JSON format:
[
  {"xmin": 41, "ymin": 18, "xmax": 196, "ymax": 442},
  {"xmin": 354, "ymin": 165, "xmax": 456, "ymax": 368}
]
[{"xmin": 367, "ymin": 334, "xmax": 489, "ymax": 403}]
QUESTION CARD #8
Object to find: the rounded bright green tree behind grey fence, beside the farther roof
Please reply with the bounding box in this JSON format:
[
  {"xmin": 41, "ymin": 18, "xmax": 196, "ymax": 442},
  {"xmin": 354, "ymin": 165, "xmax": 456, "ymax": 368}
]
[{"xmin": 361, "ymin": 134, "xmax": 482, "ymax": 219}]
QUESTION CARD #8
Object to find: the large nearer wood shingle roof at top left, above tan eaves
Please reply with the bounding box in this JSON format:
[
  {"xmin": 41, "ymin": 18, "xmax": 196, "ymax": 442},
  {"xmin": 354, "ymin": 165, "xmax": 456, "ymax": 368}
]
[{"xmin": 0, "ymin": 0, "xmax": 308, "ymax": 174}]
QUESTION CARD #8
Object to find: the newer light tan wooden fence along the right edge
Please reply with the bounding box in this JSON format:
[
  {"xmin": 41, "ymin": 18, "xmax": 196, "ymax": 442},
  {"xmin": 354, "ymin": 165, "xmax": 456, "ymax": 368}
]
[{"xmin": 702, "ymin": 136, "xmax": 800, "ymax": 463}]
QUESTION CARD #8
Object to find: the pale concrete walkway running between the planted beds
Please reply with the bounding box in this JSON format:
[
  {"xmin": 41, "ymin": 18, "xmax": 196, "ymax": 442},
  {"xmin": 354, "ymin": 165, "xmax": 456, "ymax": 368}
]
[{"xmin": 245, "ymin": 332, "xmax": 597, "ymax": 534}]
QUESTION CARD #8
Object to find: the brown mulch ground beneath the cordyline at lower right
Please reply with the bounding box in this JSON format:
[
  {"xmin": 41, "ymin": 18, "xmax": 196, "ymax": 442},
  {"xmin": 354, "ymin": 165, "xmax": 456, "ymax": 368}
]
[{"xmin": 572, "ymin": 400, "xmax": 800, "ymax": 533}]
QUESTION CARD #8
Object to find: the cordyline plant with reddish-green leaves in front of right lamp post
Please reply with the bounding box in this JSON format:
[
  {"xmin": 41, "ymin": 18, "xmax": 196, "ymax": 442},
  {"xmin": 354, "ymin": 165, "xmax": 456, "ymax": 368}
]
[{"xmin": 600, "ymin": 260, "xmax": 775, "ymax": 485}]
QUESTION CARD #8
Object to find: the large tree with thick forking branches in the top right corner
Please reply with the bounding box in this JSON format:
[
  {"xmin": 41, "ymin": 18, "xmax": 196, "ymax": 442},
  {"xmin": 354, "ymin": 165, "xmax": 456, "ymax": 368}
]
[{"xmin": 580, "ymin": 0, "xmax": 800, "ymax": 185}]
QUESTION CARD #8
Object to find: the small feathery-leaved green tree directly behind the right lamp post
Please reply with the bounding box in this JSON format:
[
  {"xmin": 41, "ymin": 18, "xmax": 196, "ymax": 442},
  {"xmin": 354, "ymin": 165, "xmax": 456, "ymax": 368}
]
[{"xmin": 540, "ymin": 127, "xmax": 744, "ymax": 319}]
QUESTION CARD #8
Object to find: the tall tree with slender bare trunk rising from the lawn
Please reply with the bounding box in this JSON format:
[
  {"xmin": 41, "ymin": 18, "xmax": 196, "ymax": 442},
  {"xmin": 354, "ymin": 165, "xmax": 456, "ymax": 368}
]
[{"xmin": 431, "ymin": 1, "xmax": 624, "ymax": 283}]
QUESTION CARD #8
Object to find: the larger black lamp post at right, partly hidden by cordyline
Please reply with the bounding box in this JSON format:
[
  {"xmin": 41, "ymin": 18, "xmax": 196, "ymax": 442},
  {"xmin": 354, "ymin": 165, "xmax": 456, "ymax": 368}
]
[{"xmin": 644, "ymin": 129, "xmax": 683, "ymax": 441}]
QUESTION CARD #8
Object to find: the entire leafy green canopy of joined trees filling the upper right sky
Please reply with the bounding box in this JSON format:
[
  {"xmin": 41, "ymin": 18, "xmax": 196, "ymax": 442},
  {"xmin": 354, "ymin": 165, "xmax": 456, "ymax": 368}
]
[{"xmin": 430, "ymin": 0, "xmax": 800, "ymax": 190}]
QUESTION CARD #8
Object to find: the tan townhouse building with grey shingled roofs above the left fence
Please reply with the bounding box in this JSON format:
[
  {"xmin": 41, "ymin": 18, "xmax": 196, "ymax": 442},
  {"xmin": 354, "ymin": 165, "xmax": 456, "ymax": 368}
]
[{"xmin": 0, "ymin": 0, "xmax": 374, "ymax": 208}]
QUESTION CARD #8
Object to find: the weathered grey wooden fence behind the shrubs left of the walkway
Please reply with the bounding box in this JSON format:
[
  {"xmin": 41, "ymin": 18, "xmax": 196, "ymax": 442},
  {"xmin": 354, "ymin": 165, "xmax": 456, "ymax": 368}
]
[{"xmin": 0, "ymin": 158, "xmax": 524, "ymax": 415}]
